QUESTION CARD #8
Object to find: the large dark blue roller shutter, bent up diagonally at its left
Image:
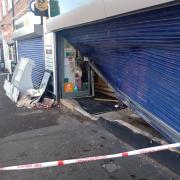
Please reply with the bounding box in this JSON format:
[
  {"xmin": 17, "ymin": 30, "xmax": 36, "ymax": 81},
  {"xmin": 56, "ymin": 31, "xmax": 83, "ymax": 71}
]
[{"xmin": 61, "ymin": 5, "xmax": 180, "ymax": 139}]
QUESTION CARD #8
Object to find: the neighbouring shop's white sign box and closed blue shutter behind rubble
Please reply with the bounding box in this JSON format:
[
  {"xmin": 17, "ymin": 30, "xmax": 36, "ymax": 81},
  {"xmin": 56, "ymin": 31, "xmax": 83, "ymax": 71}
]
[{"xmin": 13, "ymin": 12, "xmax": 45, "ymax": 88}]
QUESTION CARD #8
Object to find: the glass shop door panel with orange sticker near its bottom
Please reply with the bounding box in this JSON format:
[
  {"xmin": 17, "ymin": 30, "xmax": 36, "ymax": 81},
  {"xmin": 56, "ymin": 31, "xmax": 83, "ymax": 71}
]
[{"xmin": 62, "ymin": 39, "xmax": 91, "ymax": 98}]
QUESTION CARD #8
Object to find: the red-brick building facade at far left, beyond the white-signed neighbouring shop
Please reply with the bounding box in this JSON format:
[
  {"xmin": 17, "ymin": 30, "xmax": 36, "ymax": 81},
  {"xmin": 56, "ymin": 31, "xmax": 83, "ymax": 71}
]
[{"xmin": 0, "ymin": 0, "xmax": 28, "ymax": 72}]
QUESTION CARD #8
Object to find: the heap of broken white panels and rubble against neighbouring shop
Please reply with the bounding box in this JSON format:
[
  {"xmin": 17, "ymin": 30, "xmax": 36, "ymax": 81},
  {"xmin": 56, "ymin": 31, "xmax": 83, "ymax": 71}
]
[{"xmin": 4, "ymin": 58, "xmax": 55, "ymax": 109}]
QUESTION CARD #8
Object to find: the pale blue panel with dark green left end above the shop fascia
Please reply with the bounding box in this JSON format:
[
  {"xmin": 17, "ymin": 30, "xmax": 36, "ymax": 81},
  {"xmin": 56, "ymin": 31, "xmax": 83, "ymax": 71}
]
[{"xmin": 49, "ymin": 0, "xmax": 92, "ymax": 17}]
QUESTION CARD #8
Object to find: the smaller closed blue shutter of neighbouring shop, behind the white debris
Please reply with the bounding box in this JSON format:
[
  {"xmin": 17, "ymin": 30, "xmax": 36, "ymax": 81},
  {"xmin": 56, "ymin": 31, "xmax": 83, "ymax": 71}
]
[{"xmin": 18, "ymin": 37, "xmax": 45, "ymax": 87}]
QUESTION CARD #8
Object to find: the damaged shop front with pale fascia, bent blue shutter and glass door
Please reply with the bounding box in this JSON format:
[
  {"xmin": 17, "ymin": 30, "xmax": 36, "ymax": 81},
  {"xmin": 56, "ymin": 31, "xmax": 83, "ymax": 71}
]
[{"xmin": 46, "ymin": 0, "xmax": 180, "ymax": 142}]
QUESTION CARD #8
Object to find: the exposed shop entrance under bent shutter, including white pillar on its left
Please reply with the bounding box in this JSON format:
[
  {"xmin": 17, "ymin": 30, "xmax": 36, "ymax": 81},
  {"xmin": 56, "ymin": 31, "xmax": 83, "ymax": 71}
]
[{"xmin": 44, "ymin": 31, "xmax": 118, "ymax": 114}]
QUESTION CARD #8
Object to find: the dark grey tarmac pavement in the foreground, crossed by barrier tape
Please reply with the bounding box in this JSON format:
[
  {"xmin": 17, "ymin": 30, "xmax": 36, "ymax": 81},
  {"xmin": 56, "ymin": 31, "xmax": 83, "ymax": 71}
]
[{"xmin": 0, "ymin": 74, "xmax": 180, "ymax": 180}]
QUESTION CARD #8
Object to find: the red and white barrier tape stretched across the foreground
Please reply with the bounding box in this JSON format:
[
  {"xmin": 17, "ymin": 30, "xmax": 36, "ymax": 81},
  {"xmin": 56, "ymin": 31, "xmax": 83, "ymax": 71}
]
[{"xmin": 0, "ymin": 143, "xmax": 180, "ymax": 171}]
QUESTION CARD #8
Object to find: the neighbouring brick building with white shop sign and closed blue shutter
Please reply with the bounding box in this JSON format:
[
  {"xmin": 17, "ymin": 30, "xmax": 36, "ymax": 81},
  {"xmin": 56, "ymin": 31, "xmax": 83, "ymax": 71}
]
[{"xmin": 0, "ymin": 0, "xmax": 45, "ymax": 87}]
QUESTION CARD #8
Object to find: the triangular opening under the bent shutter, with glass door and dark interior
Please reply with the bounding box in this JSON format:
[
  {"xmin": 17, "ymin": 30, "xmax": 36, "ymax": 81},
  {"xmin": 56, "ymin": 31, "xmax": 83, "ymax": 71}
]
[{"xmin": 59, "ymin": 38, "xmax": 125, "ymax": 114}]
